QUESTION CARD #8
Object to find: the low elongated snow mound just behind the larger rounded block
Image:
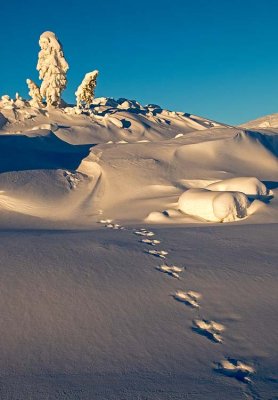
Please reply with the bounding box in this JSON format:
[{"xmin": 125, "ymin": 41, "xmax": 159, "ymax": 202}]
[{"xmin": 206, "ymin": 177, "xmax": 269, "ymax": 196}]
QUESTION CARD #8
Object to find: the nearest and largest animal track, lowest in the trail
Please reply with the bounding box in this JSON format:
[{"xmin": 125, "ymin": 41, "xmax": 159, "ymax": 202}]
[{"xmin": 215, "ymin": 359, "xmax": 255, "ymax": 383}]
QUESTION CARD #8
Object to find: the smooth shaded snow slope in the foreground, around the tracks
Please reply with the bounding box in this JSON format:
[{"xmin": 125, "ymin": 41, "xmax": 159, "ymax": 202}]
[{"xmin": 0, "ymin": 224, "xmax": 278, "ymax": 400}]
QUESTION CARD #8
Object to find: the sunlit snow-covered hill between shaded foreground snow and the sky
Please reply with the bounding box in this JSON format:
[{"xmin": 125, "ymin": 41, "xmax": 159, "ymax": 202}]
[{"xmin": 0, "ymin": 96, "xmax": 278, "ymax": 226}]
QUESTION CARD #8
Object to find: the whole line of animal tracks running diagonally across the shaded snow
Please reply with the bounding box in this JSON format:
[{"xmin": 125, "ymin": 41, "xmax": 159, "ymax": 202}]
[{"xmin": 99, "ymin": 219, "xmax": 261, "ymax": 400}]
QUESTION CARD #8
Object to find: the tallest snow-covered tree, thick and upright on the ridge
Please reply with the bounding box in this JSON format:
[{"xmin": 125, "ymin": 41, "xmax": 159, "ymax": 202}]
[{"xmin": 37, "ymin": 32, "xmax": 69, "ymax": 107}]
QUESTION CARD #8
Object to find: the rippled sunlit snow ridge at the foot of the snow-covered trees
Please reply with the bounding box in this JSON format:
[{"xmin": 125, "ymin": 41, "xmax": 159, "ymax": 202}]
[{"xmin": 0, "ymin": 96, "xmax": 224, "ymax": 144}]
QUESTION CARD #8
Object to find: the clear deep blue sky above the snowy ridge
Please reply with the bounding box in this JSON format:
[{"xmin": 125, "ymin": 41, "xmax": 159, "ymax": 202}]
[{"xmin": 0, "ymin": 0, "xmax": 278, "ymax": 124}]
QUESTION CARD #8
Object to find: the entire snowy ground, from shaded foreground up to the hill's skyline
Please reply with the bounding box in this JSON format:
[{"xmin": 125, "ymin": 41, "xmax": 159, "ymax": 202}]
[{"xmin": 0, "ymin": 98, "xmax": 278, "ymax": 400}]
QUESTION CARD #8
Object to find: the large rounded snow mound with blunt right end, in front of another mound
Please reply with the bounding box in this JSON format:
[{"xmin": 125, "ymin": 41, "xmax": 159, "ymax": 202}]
[{"xmin": 178, "ymin": 189, "xmax": 249, "ymax": 222}]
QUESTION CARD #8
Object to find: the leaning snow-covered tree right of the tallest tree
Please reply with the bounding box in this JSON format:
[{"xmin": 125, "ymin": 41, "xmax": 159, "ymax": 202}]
[{"xmin": 75, "ymin": 70, "xmax": 98, "ymax": 108}]
